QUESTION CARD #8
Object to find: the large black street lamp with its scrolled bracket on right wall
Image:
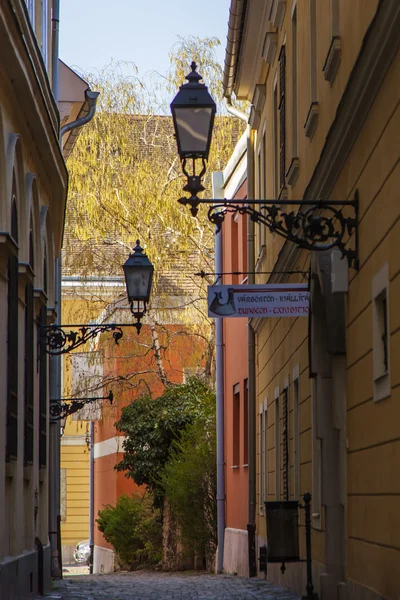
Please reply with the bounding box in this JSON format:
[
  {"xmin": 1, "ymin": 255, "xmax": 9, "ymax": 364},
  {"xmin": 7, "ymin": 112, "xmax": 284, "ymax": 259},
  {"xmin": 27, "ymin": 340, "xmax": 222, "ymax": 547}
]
[{"xmin": 171, "ymin": 63, "xmax": 358, "ymax": 268}]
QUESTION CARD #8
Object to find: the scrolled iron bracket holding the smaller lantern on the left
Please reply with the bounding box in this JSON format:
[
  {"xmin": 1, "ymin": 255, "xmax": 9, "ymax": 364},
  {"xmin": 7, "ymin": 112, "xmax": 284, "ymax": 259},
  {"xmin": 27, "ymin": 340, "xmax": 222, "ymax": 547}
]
[{"xmin": 40, "ymin": 323, "xmax": 123, "ymax": 356}]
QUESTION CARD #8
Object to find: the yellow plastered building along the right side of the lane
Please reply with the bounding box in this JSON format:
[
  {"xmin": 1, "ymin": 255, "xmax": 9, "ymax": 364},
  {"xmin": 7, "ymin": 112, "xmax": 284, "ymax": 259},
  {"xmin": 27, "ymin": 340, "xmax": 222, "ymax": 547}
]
[{"xmin": 224, "ymin": 0, "xmax": 400, "ymax": 600}]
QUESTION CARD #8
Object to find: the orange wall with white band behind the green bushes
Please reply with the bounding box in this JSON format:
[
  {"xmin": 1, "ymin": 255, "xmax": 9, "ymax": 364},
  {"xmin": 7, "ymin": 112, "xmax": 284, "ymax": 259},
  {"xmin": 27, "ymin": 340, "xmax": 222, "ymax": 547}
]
[{"xmin": 92, "ymin": 317, "xmax": 208, "ymax": 573}]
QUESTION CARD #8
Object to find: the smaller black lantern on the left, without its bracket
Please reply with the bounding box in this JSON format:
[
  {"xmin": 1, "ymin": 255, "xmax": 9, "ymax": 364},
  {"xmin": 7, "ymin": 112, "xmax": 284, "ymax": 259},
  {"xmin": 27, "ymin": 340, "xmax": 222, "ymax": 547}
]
[{"xmin": 123, "ymin": 240, "xmax": 154, "ymax": 333}]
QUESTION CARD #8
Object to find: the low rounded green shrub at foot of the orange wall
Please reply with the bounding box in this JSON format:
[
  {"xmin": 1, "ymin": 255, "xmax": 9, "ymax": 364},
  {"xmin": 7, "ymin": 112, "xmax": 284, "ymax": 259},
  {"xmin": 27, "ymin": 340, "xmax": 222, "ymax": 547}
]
[{"xmin": 96, "ymin": 495, "xmax": 162, "ymax": 569}]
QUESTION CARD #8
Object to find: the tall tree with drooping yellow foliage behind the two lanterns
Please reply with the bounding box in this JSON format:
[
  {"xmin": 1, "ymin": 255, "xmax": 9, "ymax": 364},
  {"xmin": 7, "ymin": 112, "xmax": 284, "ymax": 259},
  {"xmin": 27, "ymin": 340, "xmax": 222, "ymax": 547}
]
[{"xmin": 64, "ymin": 38, "xmax": 243, "ymax": 394}]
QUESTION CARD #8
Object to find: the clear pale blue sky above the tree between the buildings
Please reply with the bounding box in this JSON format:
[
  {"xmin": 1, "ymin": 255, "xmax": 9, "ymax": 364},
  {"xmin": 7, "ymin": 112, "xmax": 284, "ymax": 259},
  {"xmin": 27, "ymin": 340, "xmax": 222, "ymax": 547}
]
[{"xmin": 60, "ymin": 0, "xmax": 230, "ymax": 77}]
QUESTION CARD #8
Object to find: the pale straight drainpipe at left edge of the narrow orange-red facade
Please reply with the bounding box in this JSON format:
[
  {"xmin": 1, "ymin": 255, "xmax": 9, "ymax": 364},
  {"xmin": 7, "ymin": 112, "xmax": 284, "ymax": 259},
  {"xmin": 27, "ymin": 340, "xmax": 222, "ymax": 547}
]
[{"xmin": 212, "ymin": 173, "xmax": 225, "ymax": 573}]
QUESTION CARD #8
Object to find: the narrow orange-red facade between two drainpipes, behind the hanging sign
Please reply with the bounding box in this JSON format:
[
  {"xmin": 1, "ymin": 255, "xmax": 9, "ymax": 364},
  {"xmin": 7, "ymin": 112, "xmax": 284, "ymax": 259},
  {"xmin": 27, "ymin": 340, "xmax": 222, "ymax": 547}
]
[{"xmin": 214, "ymin": 133, "xmax": 249, "ymax": 576}]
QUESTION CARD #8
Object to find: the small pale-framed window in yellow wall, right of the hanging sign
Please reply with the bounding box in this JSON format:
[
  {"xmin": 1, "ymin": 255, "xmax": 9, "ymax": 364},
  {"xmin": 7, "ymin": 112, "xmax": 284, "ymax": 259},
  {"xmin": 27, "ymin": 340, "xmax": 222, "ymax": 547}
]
[{"xmin": 372, "ymin": 264, "xmax": 391, "ymax": 400}]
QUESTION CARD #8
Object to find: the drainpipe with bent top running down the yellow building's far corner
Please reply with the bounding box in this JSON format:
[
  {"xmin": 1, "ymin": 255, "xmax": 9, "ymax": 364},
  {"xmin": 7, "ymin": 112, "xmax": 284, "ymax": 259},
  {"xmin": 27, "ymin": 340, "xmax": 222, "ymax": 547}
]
[{"xmin": 225, "ymin": 97, "xmax": 257, "ymax": 577}]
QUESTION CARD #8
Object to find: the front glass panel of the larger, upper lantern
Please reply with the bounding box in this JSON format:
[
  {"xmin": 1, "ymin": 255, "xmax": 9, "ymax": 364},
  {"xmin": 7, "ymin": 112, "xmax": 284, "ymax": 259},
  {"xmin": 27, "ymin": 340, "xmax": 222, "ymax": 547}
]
[{"xmin": 175, "ymin": 108, "xmax": 212, "ymax": 156}]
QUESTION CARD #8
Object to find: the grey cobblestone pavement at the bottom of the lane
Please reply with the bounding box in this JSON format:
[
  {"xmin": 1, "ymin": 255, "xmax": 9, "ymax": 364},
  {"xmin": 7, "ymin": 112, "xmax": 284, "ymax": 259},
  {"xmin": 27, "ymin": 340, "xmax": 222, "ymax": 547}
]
[{"xmin": 49, "ymin": 571, "xmax": 300, "ymax": 600}]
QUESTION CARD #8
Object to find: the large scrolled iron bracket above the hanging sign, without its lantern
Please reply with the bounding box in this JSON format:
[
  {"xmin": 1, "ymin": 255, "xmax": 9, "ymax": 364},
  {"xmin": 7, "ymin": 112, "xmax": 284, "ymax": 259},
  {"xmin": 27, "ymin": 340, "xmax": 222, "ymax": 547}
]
[{"xmin": 179, "ymin": 192, "xmax": 359, "ymax": 269}]
